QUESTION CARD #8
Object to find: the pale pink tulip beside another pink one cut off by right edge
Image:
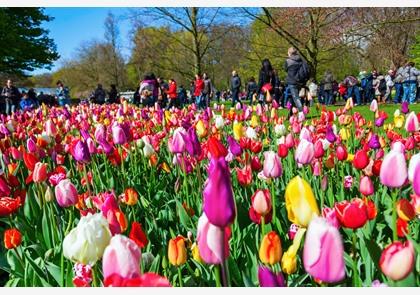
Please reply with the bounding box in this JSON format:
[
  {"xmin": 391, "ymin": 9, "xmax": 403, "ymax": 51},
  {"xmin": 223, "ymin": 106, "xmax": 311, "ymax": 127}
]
[{"xmin": 379, "ymin": 149, "xmax": 407, "ymax": 187}]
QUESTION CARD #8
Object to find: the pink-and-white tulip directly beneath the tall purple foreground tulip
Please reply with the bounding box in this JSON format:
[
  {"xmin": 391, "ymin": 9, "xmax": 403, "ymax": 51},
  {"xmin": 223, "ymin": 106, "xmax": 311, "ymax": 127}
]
[{"xmin": 197, "ymin": 213, "xmax": 231, "ymax": 264}]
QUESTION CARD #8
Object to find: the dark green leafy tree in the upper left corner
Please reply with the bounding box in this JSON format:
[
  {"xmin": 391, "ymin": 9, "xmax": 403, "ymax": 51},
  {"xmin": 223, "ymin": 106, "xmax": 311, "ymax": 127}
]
[{"xmin": 0, "ymin": 7, "xmax": 59, "ymax": 75}]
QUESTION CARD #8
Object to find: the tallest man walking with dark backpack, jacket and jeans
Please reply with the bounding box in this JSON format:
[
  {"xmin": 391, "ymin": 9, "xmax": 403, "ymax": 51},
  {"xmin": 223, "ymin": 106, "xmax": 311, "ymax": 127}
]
[{"xmin": 284, "ymin": 47, "xmax": 309, "ymax": 114}]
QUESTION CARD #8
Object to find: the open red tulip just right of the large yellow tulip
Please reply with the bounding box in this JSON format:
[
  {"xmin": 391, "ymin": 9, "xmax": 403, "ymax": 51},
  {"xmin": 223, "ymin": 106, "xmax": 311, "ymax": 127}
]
[{"xmin": 334, "ymin": 198, "xmax": 368, "ymax": 229}]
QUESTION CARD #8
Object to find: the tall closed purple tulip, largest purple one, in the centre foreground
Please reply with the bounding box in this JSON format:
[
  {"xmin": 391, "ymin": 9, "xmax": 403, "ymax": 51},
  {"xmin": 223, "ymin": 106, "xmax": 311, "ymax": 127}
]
[{"xmin": 203, "ymin": 157, "xmax": 236, "ymax": 228}]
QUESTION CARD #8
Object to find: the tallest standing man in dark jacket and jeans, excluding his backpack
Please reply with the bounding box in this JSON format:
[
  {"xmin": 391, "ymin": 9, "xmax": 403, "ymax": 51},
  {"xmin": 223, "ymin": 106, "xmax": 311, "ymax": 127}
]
[{"xmin": 284, "ymin": 47, "xmax": 303, "ymax": 112}]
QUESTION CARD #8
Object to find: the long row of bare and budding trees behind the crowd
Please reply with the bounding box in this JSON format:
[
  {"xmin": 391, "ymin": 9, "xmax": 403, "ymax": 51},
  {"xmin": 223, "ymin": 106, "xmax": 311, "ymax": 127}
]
[{"xmin": 23, "ymin": 7, "xmax": 420, "ymax": 95}]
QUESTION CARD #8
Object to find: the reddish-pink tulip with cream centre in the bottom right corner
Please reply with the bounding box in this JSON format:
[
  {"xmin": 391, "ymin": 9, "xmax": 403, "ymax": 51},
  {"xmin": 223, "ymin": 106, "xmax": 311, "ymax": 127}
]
[{"xmin": 379, "ymin": 241, "xmax": 415, "ymax": 281}]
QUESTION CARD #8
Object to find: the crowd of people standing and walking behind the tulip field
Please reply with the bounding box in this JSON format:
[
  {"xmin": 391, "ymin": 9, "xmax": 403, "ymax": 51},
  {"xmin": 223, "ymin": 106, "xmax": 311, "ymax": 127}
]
[{"xmin": 0, "ymin": 47, "xmax": 420, "ymax": 114}]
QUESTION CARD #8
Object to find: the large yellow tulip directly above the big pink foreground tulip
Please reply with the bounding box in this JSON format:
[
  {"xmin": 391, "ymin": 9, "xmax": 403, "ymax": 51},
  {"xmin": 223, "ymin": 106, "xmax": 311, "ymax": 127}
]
[{"xmin": 285, "ymin": 176, "xmax": 319, "ymax": 227}]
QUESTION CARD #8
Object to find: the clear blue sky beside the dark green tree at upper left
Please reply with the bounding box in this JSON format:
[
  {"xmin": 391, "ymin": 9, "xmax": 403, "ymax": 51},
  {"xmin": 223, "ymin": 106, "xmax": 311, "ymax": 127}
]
[{"xmin": 31, "ymin": 7, "xmax": 131, "ymax": 75}]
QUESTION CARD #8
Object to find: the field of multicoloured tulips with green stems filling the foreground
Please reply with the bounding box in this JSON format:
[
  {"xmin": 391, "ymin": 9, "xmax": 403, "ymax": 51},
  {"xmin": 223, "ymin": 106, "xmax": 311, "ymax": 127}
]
[{"xmin": 0, "ymin": 99, "xmax": 420, "ymax": 287}]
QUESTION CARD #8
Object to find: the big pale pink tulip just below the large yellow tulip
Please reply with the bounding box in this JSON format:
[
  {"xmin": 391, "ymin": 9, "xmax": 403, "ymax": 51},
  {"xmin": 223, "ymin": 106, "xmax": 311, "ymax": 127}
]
[{"xmin": 303, "ymin": 217, "xmax": 345, "ymax": 283}]
